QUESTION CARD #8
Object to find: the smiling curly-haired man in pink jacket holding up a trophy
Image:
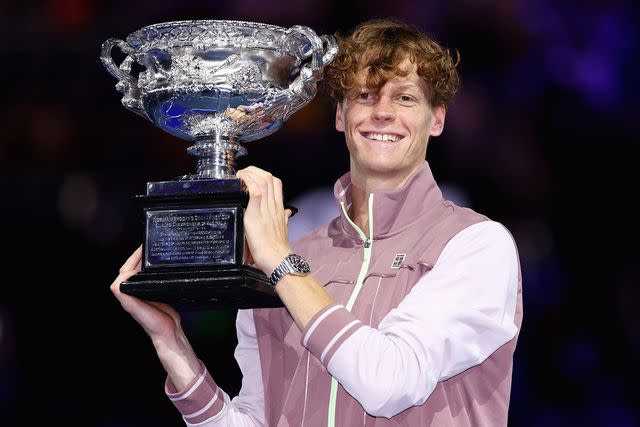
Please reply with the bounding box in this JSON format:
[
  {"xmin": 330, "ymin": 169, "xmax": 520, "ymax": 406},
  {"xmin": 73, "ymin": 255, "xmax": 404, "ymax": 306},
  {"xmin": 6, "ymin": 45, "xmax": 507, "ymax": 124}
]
[{"xmin": 112, "ymin": 20, "xmax": 522, "ymax": 426}]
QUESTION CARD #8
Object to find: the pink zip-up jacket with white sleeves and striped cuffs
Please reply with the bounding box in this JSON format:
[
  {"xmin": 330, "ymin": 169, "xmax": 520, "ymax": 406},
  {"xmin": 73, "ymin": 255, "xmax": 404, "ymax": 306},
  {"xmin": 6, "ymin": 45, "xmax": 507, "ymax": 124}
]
[{"xmin": 165, "ymin": 162, "xmax": 522, "ymax": 426}]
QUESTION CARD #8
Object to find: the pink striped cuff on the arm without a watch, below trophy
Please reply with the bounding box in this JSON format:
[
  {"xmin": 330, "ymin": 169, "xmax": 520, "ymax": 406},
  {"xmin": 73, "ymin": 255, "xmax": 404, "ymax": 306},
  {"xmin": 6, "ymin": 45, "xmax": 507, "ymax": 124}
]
[{"xmin": 164, "ymin": 362, "xmax": 224, "ymax": 424}]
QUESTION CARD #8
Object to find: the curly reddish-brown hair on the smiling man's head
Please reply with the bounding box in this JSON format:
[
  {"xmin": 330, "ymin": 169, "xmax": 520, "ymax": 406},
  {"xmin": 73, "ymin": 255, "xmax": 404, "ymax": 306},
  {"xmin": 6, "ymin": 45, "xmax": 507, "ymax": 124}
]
[{"xmin": 324, "ymin": 19, "xmax": 460, "ymax": 107}]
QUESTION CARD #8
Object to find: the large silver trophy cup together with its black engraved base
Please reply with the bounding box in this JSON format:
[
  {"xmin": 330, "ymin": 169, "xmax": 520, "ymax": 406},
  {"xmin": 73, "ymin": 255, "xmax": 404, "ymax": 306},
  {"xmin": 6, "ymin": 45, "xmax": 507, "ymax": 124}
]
[{"xmin": 100, "ymin": 20, "xmax": 338, "ymax": 308}]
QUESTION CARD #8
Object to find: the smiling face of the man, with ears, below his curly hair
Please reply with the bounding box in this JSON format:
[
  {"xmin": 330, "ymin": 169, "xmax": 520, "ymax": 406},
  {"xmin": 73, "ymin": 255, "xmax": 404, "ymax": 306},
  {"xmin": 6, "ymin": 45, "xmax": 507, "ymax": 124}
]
[{"xmin": 336, "ymin": 61, "xmax": 445, "ymax": 188}]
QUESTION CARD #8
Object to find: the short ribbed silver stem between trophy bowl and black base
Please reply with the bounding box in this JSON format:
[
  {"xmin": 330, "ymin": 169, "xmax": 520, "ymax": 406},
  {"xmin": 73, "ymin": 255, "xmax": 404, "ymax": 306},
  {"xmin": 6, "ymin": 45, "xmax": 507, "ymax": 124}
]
[{"xmin": 187, "ymin": 134, "xmax": 247, "ymax": 179}]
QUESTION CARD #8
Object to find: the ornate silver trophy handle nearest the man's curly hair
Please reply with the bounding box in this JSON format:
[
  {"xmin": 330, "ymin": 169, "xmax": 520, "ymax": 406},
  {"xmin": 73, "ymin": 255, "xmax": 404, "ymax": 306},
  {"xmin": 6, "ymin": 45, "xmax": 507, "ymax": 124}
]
[{"xmin": 283, "ymin": 25, "xmax": 338, "ymax": 120}]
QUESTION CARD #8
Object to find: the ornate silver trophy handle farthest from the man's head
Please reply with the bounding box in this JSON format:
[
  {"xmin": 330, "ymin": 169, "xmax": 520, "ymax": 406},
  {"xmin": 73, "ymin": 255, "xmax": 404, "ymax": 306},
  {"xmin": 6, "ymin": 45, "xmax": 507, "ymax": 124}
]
[{"xmin": 100, "ymin": 38, "xmax": 151, "ymax": 121}]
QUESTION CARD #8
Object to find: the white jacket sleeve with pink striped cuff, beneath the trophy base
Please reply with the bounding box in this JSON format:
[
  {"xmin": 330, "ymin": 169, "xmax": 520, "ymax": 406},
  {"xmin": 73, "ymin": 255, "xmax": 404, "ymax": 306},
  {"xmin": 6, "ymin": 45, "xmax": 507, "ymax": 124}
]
[{"xmin": 165, "ymin": 310, "xmax": 264, "ymax": 427}]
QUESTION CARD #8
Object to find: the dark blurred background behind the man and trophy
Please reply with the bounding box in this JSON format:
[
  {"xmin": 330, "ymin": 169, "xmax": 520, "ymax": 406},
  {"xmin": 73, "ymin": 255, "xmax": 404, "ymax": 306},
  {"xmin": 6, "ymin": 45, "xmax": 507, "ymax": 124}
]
[{"xmin": 0, "ymin": 0, "xmax": 640, "ymax": 427}]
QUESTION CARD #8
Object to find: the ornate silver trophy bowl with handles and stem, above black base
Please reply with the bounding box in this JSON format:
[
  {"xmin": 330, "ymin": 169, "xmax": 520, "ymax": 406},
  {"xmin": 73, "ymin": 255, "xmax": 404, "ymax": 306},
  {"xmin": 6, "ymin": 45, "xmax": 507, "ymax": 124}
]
[{"xmin": 100, "ymin": 20, "xmax": 337, "ymax": 178}]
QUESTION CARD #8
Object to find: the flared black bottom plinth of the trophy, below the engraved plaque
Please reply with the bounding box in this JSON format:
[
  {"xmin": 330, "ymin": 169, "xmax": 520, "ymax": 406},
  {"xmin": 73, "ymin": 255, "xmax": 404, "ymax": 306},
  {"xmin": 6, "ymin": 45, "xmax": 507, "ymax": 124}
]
[{"xmin": 120, "ymin": 265, "xmax": 283, "ymax": 309}]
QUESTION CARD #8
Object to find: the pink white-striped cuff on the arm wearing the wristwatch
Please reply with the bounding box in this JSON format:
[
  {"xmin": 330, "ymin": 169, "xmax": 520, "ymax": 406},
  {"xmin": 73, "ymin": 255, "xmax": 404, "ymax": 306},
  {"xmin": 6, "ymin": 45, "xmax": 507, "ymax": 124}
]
[{"xmin": 301, "ymin": 304, "xmax": 365, "ymax": 367}]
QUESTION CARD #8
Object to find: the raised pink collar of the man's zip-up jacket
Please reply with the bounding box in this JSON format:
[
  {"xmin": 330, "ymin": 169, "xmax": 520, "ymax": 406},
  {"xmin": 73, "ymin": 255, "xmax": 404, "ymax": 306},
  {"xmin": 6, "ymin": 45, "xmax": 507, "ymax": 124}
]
[{"xmin": 329, "ymin": 161, "xmax": 442, "ymax": 239}]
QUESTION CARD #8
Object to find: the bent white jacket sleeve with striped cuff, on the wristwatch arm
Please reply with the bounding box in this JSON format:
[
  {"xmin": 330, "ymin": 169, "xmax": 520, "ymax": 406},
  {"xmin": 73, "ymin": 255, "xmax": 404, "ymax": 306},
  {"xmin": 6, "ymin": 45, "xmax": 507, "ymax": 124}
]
[{"xmin": 302, "ymin": 221, "xmax": 519, "ymax": 417}]
